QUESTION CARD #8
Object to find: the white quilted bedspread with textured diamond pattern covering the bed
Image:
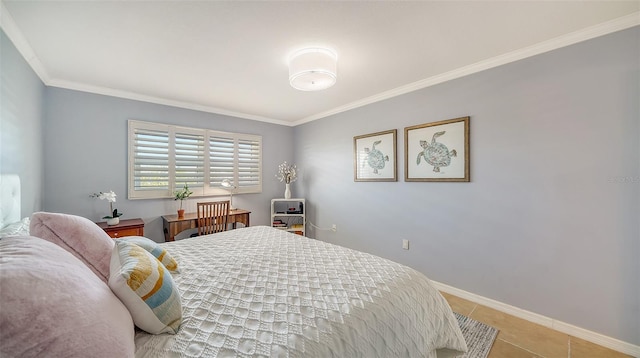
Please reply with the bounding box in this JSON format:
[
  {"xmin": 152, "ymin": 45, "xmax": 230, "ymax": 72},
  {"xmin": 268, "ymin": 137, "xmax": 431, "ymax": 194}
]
[{"xmin": 135, "ymin": 226, "xmax": 466, "ymax": 358}]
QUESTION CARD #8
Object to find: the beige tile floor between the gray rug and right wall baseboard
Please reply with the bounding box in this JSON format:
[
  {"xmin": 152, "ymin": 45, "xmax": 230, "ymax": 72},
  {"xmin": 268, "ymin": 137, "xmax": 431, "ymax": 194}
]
[{"xmin": 442, "ymin": 292, "xmax": 631, "ymax": 358}]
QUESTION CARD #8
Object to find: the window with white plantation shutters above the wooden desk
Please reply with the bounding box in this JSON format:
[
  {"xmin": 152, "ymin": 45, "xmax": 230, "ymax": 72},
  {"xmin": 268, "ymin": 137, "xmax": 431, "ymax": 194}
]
[{"xmin": 129, "ymin": 120, "xmax": 262, "ymax": 199}]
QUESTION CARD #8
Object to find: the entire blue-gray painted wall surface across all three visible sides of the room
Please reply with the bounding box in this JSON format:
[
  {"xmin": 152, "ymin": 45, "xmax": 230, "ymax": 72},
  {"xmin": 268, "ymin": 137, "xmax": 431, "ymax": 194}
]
[{"xmin": 0, "ymin": 23, "xmax": 640, "ymax": 344}]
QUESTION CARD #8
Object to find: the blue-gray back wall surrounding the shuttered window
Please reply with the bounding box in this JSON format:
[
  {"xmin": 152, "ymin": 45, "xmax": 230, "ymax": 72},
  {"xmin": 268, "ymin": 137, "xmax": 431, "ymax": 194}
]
[{"xmin": 44, "ymin": 88, "xmax": 293, "ymax": 241}]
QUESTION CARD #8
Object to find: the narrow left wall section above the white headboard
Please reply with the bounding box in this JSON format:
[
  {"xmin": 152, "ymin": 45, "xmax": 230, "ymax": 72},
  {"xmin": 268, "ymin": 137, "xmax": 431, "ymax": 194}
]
[{"xmin": 0, "ymin": 31, "xmax": 45, "ymax": 217}]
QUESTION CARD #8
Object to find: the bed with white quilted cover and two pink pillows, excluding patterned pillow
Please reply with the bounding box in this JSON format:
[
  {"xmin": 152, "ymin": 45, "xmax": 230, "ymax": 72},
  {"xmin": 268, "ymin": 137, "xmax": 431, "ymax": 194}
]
[{"xmin": 0, "ymin": 176, "xmax": 466, "ymax": 358}]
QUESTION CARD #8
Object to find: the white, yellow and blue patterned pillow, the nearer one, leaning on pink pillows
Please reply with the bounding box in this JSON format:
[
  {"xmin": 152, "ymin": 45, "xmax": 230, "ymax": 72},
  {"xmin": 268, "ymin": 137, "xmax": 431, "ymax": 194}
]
[{"xmin": 109, "ymin": 239, "xmax": 182, "ymax": 334}]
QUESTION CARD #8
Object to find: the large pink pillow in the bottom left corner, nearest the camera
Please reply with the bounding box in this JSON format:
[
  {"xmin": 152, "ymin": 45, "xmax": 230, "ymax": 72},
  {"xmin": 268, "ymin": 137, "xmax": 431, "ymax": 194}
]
[{"xmin": 0, "ymin": 236, "xmax": 135, "ymax": 358}]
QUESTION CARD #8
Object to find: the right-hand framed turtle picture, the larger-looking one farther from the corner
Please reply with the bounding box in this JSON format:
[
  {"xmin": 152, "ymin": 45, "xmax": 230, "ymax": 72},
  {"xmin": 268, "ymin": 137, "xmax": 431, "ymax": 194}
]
[{"xmin": 404, "ymin": 117, "xmax": 470, "ymax": 182}]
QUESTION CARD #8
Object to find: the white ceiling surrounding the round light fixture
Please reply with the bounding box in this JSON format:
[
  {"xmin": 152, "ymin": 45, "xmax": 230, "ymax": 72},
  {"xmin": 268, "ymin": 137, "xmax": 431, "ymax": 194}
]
[{"xmin": 0, "ymin": 0, "xmax": 640, "ymax": 125}]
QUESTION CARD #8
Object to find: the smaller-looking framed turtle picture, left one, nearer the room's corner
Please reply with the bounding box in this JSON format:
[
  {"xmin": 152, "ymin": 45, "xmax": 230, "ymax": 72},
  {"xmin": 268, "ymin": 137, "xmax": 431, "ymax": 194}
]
[{"xmin": 353, "ymin": 129, "xmax": 398, "ymax": 181}]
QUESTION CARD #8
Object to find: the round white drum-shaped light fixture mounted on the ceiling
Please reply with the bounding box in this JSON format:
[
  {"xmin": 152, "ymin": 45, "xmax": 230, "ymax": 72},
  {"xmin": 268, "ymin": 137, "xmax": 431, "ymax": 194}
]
[{"xmin": 289, "ymin": 47, "xmax": 338, "ymax": 91}]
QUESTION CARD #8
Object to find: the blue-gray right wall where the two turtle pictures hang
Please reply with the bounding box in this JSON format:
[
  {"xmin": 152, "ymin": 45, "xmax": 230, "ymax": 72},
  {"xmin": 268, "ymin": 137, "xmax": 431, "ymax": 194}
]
[{"xmin": 294, "ymin": 27, "xmax": 640, "ymax": 344}]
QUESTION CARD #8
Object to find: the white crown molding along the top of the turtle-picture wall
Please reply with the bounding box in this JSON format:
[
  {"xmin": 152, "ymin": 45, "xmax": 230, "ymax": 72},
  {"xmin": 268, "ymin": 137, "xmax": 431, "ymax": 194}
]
[{"xmin": 293, "ymin": 12, "xmax": 640, "ymax": 126}]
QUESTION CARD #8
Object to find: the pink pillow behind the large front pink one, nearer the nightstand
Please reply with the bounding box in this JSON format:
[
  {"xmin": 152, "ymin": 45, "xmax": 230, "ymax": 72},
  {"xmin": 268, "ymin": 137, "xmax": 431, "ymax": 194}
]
[{"xmin": 29, "ymin": 212, "xmax": 114, "ymax": 283}]
